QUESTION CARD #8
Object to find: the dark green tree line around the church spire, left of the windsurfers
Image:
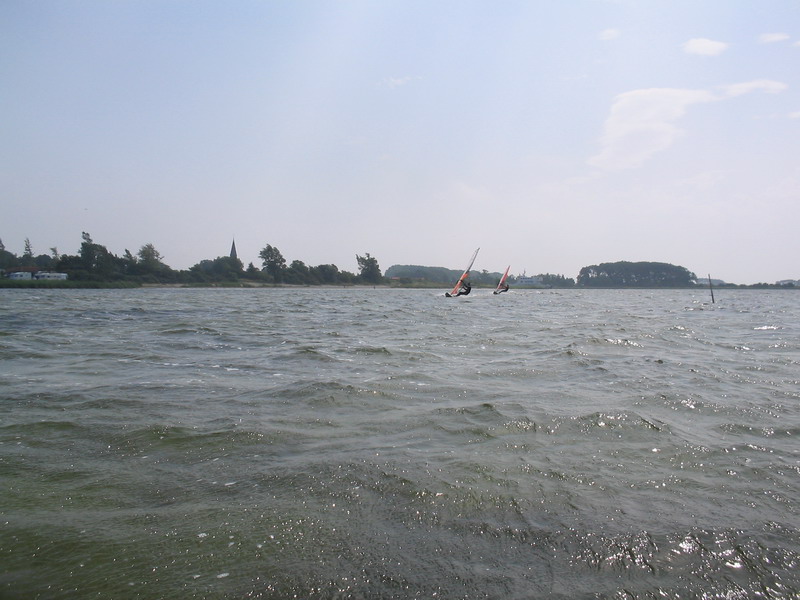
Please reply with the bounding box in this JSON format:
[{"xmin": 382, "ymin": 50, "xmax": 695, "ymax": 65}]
[{"xmin": 0, "ymin": 231, "xmax": 383, "ymax": 285}]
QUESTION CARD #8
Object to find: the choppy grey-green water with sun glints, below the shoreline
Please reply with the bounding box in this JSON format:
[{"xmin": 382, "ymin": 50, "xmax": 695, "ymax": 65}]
[{"xmin": 0, "ymin": 288, "xmax": 800, "ymax": 599}]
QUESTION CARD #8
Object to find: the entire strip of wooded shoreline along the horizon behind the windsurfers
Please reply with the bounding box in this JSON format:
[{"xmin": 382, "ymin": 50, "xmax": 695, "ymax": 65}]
[{"xmin": 0, "ymin": 232, "xmax": 800, "ymax": 289}]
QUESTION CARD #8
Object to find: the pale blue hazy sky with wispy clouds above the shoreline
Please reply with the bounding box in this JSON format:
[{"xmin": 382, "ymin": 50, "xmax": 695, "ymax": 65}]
[{"xmin": 0, "ymin": 0, "xmax": 800, "ymax": 284}]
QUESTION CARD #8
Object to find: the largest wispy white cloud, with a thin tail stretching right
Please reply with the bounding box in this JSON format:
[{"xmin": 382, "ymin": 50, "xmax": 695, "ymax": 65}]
[{"xmin": 588, "ymin": 79, "xmax": 787, "ymax": 170}]
